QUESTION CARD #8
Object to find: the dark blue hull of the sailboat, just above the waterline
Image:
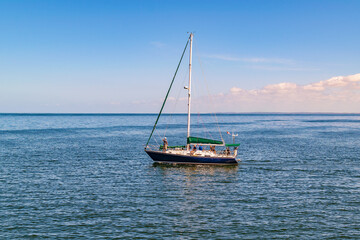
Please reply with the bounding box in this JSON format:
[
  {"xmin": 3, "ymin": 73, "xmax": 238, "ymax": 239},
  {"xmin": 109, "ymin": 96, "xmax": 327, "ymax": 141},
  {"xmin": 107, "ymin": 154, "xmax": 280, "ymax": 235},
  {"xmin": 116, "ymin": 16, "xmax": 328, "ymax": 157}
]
[{"xmin": 145, "ymin": 150, "xmax": 238, "ymax": 165}]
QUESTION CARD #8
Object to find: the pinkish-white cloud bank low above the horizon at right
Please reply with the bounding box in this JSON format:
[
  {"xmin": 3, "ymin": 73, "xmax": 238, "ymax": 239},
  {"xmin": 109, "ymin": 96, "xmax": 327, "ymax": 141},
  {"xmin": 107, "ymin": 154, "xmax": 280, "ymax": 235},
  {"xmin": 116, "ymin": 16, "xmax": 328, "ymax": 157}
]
[{"xmin": 198, "ymin": 73, "xmax": 360, "ymax": 113}]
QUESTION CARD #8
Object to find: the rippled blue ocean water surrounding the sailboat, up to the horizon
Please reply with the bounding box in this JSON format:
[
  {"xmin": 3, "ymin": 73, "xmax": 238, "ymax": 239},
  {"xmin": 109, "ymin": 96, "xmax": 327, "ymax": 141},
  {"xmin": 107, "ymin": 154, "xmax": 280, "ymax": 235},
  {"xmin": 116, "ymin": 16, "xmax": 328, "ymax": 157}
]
[{"xmin": 0, "ymin": 114, "xmax": 360, "ymax": 239}]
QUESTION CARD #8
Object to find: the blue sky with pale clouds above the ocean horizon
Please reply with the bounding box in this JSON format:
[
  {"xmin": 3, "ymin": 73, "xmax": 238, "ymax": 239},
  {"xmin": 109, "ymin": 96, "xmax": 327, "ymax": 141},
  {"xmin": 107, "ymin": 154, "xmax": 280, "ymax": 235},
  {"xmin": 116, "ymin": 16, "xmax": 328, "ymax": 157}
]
[{"xmin": 0, "ymin": 0, "xmax": 360, "ymax": 113}]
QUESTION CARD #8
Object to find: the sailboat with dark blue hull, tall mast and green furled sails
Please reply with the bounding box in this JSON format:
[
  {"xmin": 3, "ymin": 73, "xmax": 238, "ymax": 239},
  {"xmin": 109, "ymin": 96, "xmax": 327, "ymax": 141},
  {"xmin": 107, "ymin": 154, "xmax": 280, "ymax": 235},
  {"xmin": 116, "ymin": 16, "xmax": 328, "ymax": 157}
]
[{"xmin": 145, "ymin": 33, "xmax": 240, "ymax": 165}]
